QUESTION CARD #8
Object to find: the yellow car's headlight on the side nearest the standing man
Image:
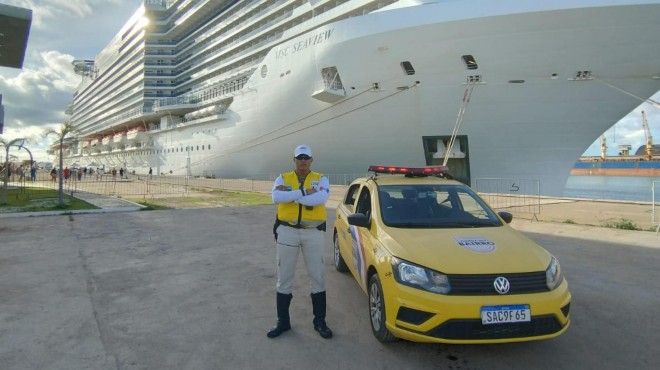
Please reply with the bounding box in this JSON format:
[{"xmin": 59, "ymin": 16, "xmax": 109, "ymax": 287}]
[{"xmin": 392, "ymin": 258, "xmax": 451, "ymax": 294}]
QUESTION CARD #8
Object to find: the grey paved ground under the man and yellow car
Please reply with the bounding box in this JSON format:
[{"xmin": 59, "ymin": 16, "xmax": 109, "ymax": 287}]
[{"xmin": 0, "ymin": 206, "xmax": 660, "ymax": 370}]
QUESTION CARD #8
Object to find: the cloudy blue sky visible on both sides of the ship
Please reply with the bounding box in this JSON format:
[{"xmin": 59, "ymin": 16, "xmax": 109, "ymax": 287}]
[{"xmin": 0, "ymin": 0, "xmax": 660, "ymax": 162}]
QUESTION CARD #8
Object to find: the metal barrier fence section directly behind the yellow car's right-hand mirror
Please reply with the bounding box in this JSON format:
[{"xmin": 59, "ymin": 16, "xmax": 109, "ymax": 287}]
[{"xmin": 475, "ymin": 178, "xmax": 541, "ymax": 221}]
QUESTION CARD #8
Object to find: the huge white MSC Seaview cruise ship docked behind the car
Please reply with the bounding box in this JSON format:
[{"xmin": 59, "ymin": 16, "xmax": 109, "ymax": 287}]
[{"xmin": 56, "ymin": 0, "xmax": 660, "ymax": 195}]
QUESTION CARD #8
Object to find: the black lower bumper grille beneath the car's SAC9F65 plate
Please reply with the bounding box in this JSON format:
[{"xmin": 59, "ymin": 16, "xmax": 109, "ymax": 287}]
[{"xmin": 426, "ymin": 315, "xmax": 562, "ymax": 340}]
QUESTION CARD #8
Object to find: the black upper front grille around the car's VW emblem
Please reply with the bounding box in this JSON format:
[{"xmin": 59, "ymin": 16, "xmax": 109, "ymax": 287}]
[{"xmin": 447, "ymin": 271, "xmax": 549, "ymax": 295}]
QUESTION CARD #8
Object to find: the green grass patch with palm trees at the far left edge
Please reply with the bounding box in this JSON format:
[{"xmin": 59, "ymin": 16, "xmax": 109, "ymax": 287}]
[{"xmin": 0, "ymin": 188, "xmax": 98, "ymax": 213}]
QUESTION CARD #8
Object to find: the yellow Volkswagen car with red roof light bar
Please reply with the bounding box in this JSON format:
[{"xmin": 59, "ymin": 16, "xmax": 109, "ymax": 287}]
[{"xmin": 333, "ymin": 166, "xmax": 571, "ymax": 343}]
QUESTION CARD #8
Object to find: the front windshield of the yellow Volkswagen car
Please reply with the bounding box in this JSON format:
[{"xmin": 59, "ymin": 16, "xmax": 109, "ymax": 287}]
[{"xmin": 378, "ymin": 185, "xmax": 502, "ymax": 228}]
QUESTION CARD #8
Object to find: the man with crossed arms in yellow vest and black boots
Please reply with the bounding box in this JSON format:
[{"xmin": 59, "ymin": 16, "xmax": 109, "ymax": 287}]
[{"xmin": 266, "ymin": 145, "xmax": 332, "ymax": 338}]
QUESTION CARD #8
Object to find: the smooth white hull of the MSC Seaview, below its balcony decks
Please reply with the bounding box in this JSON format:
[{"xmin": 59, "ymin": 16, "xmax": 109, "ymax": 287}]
[{"xmin": 62, "ymin": 1, "xmax": 660, "ymax": 195}]
